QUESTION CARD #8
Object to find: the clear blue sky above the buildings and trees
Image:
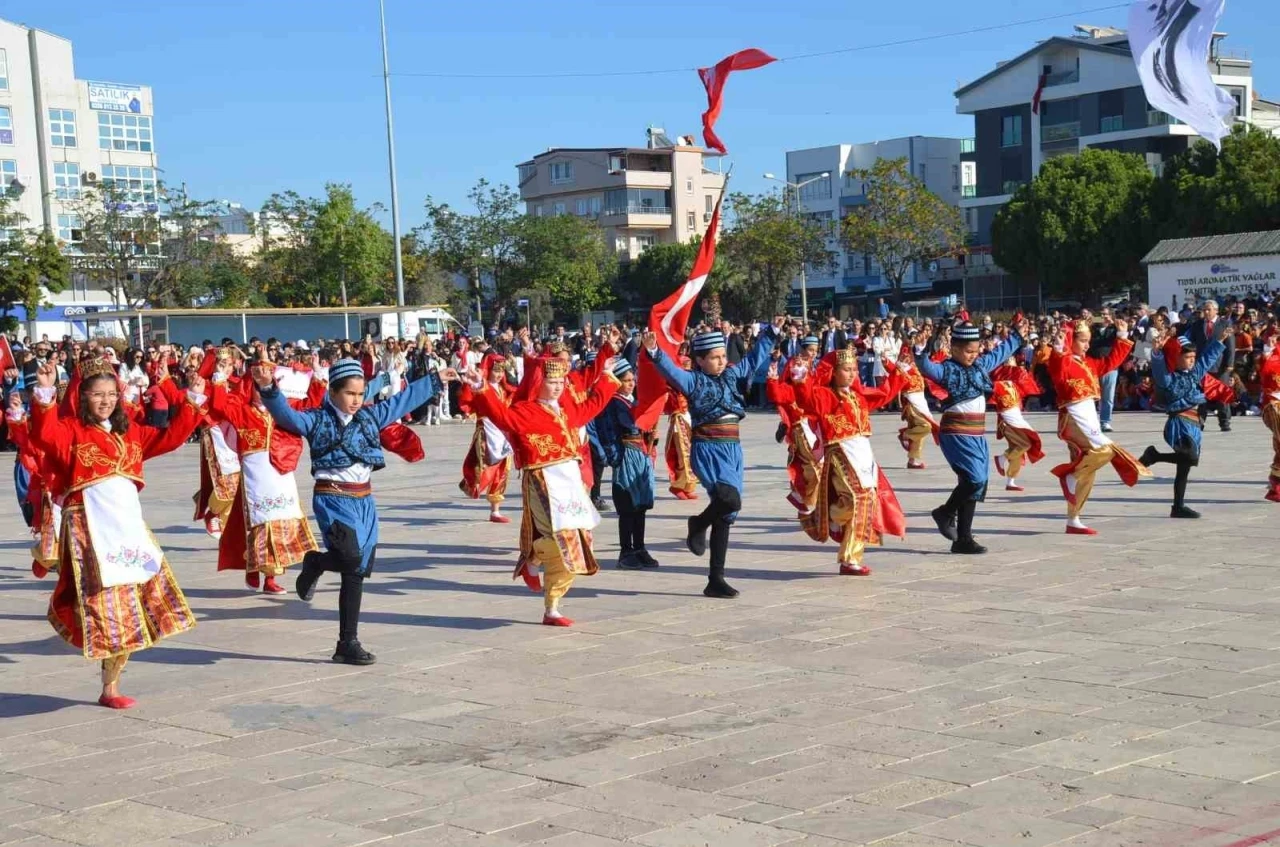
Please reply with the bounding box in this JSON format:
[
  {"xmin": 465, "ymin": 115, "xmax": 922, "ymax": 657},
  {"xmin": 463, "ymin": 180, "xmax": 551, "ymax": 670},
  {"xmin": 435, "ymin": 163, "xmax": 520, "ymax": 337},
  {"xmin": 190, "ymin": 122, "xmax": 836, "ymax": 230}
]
[{"xmin": 12, "ymin": 0, "xmax": 1280, "ymax": 228}]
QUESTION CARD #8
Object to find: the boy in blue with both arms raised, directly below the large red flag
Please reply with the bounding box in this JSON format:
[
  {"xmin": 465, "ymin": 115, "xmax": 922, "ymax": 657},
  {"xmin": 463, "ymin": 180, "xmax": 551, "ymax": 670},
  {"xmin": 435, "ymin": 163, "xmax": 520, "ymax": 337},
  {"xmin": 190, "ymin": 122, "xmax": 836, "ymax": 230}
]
[{"xmin": 646, "ymin": 326, "xmax": 777, "ymax": 598}]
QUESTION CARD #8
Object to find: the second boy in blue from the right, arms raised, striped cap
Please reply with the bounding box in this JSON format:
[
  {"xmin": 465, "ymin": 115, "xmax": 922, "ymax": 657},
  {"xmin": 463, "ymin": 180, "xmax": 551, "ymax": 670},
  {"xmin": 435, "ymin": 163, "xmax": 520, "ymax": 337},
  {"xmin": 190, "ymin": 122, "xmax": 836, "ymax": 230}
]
[{"xmin": 915, "ymin": 324, "xmax": 1023, "ymax": 553}]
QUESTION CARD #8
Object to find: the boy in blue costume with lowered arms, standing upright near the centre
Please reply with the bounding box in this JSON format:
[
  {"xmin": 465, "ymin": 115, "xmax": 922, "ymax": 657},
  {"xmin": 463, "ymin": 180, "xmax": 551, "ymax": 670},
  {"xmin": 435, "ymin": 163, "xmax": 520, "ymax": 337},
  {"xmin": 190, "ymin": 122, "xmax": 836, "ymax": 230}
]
[{"xmin": 593, "ymin": 358, "xmax": 658, "ymax": 571}]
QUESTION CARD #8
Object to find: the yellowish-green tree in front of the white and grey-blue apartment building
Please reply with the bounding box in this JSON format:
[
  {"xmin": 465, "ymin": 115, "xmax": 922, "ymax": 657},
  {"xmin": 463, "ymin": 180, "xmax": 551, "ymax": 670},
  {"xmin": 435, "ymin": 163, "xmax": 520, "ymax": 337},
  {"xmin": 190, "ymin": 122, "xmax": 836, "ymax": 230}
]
[{"xmin": 842, "ymin": 159, "xmax": 964, "ymax": 292}]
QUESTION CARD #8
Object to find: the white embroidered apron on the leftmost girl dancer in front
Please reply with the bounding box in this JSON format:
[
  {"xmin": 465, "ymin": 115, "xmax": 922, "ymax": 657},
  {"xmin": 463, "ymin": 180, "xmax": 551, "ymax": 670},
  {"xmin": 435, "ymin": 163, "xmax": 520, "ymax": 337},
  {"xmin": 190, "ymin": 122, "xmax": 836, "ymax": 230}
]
[{"xmin": 81, "ymin": 476, "xmax": 163, "ymax": 589}]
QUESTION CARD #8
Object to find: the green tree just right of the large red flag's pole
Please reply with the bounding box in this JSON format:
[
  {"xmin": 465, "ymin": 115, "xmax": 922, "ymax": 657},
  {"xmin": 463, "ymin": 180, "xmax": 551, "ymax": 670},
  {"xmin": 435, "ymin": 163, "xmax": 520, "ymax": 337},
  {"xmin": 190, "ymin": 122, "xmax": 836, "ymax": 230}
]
[{"xmin": 708, "ymin": 192, "xmax": 835, "ymax": 320}]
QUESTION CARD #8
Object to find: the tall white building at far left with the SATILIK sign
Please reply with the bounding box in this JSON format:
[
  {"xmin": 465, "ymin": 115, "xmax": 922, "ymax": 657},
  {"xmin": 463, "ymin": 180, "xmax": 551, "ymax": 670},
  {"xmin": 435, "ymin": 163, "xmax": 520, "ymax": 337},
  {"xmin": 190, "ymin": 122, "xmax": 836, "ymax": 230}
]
[{"xmin": 0, "ymin": 20, "xmax": 159, "ymax": 338}]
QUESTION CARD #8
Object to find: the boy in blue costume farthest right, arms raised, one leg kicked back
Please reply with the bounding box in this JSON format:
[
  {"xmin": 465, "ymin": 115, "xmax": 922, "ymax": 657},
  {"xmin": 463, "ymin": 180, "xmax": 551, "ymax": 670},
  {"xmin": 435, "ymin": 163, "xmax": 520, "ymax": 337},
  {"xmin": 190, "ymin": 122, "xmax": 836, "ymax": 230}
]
[{"xmin": 1140, "ymin": 338, "xmax": 1226, "ymax": 518}]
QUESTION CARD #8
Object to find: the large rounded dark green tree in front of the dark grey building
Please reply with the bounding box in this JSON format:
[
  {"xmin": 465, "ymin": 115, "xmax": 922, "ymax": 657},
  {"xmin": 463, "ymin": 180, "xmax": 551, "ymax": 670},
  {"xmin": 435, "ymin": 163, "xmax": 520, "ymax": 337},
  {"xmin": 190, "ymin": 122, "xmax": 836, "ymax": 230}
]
[{"xmin": 991, "ymin": 150, "xmax": 1155, "ymax": 305}]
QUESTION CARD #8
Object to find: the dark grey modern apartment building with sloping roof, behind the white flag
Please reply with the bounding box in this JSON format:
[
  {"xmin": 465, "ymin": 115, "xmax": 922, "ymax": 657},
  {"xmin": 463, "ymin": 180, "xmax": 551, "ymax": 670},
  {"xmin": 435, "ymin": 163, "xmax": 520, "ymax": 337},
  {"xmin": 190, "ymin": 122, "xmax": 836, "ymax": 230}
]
[{"xmin": 955, "ymin": 26, "xmax": 1259, "ymax": 246}]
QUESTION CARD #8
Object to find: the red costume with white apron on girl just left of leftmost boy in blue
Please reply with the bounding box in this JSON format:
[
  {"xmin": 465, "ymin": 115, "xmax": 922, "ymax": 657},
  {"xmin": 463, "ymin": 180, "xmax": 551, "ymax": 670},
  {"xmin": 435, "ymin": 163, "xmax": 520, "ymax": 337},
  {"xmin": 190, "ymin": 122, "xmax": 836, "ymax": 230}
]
[{"xmin": 209, "ymin": 380, "xmax": 320, "ymax": 594}]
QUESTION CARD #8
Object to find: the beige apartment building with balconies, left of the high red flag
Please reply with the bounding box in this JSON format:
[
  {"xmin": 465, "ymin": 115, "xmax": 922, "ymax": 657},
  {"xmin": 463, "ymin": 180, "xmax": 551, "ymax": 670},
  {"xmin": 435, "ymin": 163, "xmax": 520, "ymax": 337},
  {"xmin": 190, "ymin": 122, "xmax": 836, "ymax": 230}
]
[{"xmin": 517, "ymin": 127, "xmax": 724, "ymax": 262}]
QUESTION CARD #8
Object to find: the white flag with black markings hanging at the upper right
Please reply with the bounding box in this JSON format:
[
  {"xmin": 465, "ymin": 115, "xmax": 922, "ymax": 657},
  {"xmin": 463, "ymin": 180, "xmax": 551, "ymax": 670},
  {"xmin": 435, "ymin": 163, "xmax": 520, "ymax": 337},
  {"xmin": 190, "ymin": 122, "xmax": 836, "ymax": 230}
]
[{"xmin": 1129, "ymin": 0, "xmax": 1235, "ymax": 150}]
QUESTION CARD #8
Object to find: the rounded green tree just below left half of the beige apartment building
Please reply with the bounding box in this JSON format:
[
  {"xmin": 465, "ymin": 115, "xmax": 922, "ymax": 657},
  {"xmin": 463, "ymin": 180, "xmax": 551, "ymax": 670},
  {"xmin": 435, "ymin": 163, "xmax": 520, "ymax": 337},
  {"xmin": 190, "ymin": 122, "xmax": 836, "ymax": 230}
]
[{"xmin": 512, "ymin": 215, "xmax": 617, "ymax": 316}]
